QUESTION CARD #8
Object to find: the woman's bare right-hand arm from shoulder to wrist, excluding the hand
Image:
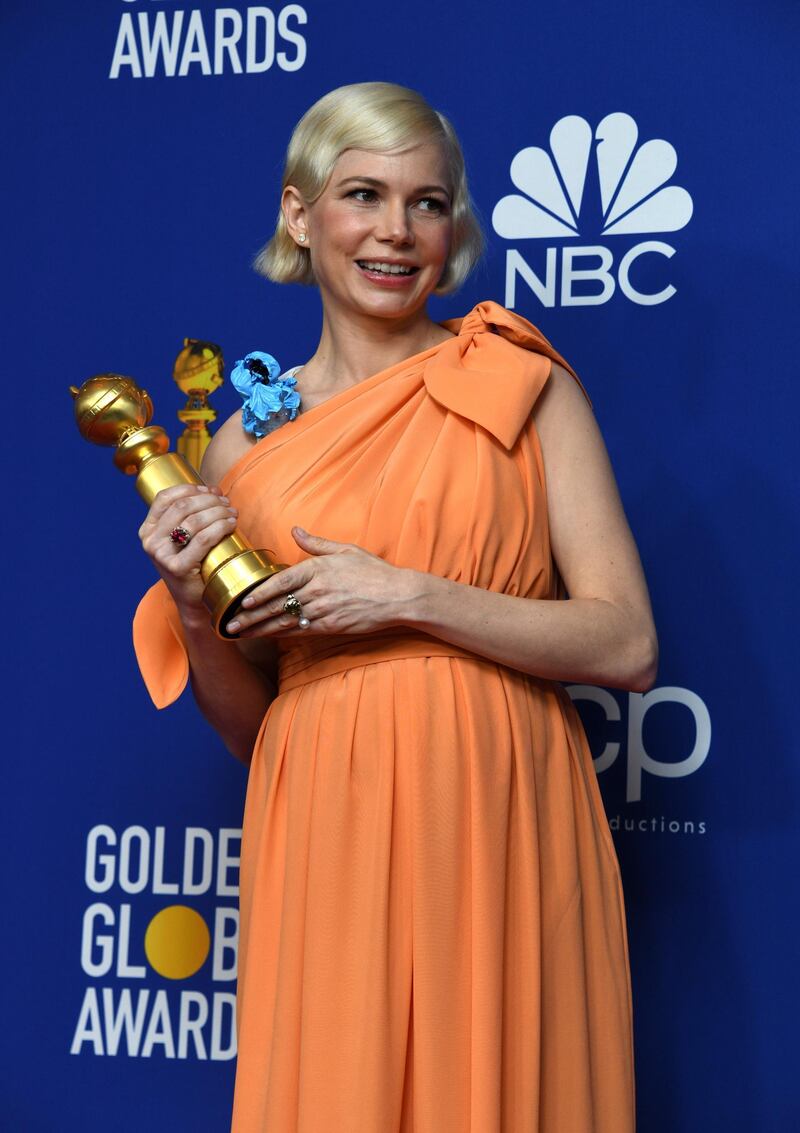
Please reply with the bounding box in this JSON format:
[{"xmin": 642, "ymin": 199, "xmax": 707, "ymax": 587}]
[{"xmin": 400, "ymin": 363, "xmax": 658, "ymax": 692}]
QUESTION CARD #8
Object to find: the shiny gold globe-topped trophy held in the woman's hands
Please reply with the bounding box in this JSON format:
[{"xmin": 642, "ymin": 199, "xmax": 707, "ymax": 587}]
[{"xmin": 69, "ymin": 374, "xmax": 286, "ymax": 639}]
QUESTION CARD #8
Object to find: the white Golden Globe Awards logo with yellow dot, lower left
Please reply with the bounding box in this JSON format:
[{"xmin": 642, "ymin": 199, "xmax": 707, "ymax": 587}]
[{"xmin": 69, "ymin": 823, "xmax": 241, "ymax": 1062}]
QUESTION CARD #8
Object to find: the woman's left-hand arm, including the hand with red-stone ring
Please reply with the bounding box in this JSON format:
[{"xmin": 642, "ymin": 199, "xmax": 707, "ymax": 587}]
[{"xmin": 139, "ymin": 412, "xmax": 276, "ymax": 764}]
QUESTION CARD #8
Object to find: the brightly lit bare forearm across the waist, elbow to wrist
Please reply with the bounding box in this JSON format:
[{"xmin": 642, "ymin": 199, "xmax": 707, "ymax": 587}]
[{"xmin": 398, "ymin": 571, "xmax": 657, "ymax": 691}]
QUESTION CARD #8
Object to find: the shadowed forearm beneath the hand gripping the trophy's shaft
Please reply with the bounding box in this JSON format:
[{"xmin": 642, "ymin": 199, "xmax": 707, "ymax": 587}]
[{"xmin": 181, "ymin": 612, "xmax": 276, "ymax": 764}]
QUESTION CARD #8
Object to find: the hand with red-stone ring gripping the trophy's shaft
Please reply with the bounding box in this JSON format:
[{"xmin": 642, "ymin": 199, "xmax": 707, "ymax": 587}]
[{"xmin": 139, "ymin": 484, "xmax": 238, "ymax": 619}]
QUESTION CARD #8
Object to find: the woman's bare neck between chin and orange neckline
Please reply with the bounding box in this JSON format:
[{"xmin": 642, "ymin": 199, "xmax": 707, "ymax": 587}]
[{"xmin": 301, "ymin": 307, "xmax": 452, "ymax": 393}]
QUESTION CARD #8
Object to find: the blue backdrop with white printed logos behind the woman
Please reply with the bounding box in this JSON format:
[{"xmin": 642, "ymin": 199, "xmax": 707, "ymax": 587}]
[{"xmin": 0, "ymin": 0, "xmax": 800, "ymax": 1133}]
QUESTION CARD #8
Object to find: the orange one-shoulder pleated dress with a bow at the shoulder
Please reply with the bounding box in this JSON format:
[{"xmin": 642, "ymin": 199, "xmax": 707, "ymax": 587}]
[{"xmin": 135, "ymin": 303, "xmax": 635, "ymax": 1133}]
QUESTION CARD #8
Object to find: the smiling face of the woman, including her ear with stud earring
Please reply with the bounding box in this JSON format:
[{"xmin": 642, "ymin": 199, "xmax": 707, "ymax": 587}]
[{"xmin": 284, "ymin": 143, "xmax": 452, "ymax": 318}]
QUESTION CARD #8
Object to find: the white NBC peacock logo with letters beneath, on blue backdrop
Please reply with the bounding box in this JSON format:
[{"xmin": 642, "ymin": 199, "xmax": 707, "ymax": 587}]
[{"xmin": 492, "ymin": 112, "xmax": 693, "ymax": 307}]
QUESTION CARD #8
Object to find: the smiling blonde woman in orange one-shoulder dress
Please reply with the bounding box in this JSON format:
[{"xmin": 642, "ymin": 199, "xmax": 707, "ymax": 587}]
[{"xmin": 135, "ymin": 83, "xmax": 656, "ymax": 1133}]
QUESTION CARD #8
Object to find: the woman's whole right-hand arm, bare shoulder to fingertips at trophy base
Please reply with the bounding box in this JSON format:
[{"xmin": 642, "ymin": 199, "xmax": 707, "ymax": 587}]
[{"xmin": 231, "ymin": 364, "xmax": 657, "ymax": 691}]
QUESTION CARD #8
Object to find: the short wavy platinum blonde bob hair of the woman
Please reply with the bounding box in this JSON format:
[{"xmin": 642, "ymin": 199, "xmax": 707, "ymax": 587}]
[{"xmin": 253, "ymin": 83, "xmax": 484, "ymax": 295}]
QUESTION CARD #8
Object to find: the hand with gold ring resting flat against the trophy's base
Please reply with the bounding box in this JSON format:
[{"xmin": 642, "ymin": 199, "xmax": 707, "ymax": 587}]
[{"xmin": 228, "ymin": 527, "xmax": 407, "ymax": 638}]
